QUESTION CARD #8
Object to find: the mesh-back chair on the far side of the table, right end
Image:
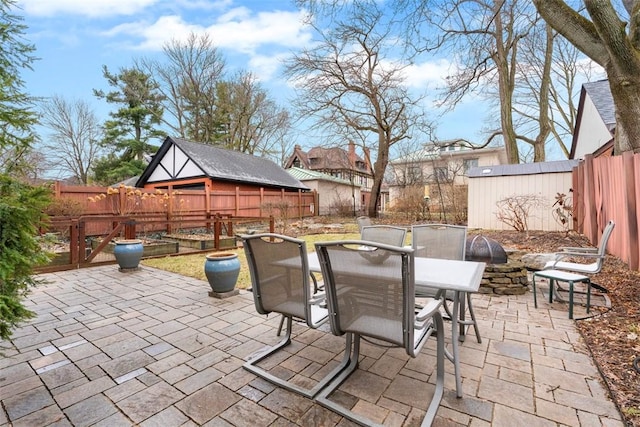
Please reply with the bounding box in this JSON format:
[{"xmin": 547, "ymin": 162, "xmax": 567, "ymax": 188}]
[{"xmin": 411, "ymin": 224, "xmax": 482, "ymax": 343}]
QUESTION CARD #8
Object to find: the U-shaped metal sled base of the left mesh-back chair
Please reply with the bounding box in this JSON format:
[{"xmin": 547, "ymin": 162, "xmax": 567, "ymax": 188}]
[{"xmin": 243, "ymin": 315, "xmax": 351, "ymax": 399}]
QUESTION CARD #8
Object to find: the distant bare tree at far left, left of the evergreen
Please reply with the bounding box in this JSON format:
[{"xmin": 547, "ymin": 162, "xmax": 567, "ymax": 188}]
[{"xmin": 41, "ymin": 95, "xmax": 104, "ymax": 184}]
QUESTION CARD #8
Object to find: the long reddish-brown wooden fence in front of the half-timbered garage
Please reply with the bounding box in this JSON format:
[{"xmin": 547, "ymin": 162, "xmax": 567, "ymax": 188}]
[{"xmin": 48, "ymin": 182, "xmax": 318, "ymax": 235}]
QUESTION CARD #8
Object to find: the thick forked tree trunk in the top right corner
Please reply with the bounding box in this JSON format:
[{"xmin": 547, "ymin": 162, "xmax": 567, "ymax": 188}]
[{"xmin": 533, "ymin": 0, "xmax": 640, "ymax": 154}]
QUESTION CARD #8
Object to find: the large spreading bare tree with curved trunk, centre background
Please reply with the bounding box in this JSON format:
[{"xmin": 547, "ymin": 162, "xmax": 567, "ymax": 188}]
[{"xmin": 286, "ymin": 8, "xmax": 424, "ymax": 217}]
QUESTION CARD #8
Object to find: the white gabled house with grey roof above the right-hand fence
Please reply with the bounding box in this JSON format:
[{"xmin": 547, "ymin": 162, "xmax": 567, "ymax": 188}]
[{"xmin": 569, "ymin": 80, "xmax": 616, "ymax": 159}]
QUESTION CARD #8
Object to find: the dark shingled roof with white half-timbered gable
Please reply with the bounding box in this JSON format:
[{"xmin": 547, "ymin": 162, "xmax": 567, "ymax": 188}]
[{"xmin": 137, "ymin": 137, "xmax": 309, "ymax": 190}]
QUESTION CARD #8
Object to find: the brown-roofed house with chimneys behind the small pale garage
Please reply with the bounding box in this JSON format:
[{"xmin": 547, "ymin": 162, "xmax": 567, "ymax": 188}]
[{"xmin": 285, "ymin": 142, "xmax": 387, "ymax": 211}]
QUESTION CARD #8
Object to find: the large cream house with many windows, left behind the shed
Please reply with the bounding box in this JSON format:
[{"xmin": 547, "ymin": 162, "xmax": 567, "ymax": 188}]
[{"xmin": 388, "ymin": 139, "xmax": 507, "ymax": 205}]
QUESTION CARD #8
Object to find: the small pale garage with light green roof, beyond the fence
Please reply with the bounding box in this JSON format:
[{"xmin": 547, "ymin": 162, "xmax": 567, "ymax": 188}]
[{"xmin": 287, "ymin": 167, "xmax": 364, "ymax": 215}]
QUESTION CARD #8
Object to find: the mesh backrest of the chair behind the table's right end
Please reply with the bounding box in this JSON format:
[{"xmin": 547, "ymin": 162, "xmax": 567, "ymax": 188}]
[{"xmin": 411, "ymin": 224, "xmax": 467, "ymax": 260}]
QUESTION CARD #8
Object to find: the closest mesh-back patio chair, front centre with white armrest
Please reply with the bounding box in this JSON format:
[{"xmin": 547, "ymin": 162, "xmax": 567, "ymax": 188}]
[{"xmin": 315, "ymin": 240, "xmax": 445, "ymax": 426}]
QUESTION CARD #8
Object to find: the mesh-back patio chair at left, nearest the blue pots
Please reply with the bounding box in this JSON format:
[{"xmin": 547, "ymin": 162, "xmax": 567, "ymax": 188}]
[{"xmin": 241, "ymin": 233, "xmax": 347, "ymax": 398}]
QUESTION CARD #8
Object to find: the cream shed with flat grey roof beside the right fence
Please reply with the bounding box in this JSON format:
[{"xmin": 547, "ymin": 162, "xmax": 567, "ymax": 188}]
[{"xmin": 467, "ymin": 160, "xmax": 578, "ymax": 231}]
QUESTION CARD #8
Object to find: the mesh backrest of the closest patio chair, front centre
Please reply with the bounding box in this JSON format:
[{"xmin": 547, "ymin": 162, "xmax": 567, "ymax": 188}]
[{"xmin": 316, "ymin": 240, "xmax": 419, "ymax": 357}]
